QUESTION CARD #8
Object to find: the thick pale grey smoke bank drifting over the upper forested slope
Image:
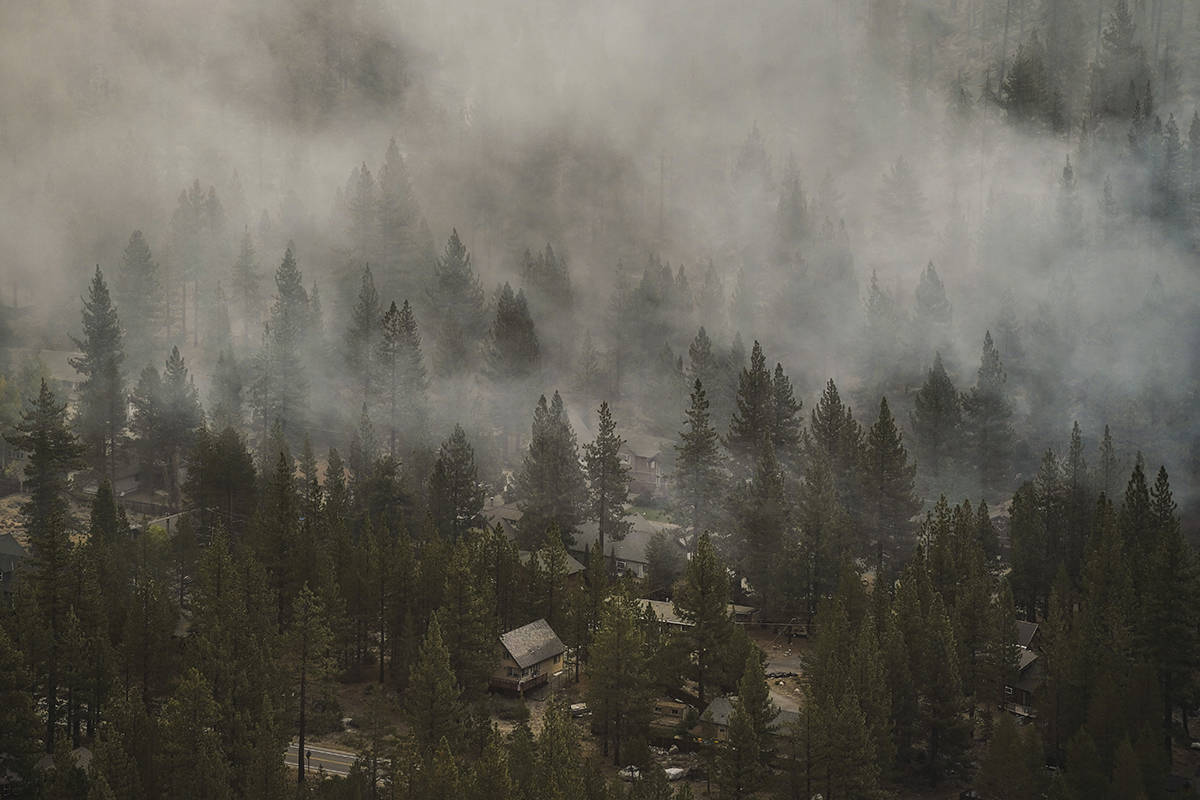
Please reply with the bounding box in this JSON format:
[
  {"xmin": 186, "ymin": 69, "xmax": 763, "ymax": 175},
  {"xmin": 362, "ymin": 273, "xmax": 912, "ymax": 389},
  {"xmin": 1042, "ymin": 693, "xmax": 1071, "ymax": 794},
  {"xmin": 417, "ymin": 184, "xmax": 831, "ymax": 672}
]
[{"xmin": 0, "ymin": 0, "xmax": 1200, "ymax": 513}]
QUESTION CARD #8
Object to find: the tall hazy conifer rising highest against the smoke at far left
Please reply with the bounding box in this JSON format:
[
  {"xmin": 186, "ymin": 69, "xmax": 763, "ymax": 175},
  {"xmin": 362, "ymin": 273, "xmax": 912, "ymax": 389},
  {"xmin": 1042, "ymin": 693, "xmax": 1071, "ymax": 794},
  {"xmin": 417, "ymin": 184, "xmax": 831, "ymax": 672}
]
[{"xmin": 71, "ymin": 266, "xmax": 126, "ymax": 480}]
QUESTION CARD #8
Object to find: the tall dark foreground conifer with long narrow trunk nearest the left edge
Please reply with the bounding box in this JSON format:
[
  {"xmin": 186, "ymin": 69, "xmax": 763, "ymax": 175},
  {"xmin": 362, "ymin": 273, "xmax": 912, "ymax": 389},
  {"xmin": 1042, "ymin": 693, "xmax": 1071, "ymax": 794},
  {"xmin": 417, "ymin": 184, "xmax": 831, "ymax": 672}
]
[{"xmin": 6, "ymin": 380, "xmax": 83, "ymax": 753}]
